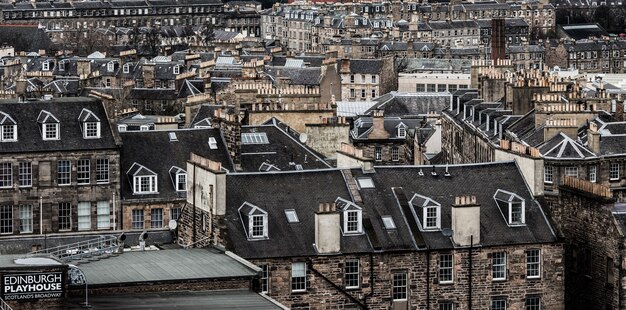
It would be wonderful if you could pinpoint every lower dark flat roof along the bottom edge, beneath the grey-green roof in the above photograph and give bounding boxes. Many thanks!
[69,290,286,310]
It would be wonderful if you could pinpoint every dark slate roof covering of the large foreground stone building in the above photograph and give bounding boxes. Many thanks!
[225,161,557,259]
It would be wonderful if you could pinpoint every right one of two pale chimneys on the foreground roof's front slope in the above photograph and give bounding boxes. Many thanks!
[452,196,480,246]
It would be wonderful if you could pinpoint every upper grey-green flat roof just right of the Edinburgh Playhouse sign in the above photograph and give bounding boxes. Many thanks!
[78,248,257,286]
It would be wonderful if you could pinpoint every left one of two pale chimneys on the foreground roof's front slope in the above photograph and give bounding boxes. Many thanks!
[315,202,341,254]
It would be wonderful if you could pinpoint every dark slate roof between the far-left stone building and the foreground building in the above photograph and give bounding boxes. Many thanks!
[120,129,232,201]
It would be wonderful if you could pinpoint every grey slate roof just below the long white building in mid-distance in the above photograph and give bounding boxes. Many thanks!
[365,91,452,117]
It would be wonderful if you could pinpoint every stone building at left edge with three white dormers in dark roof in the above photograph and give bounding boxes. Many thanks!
[0,98,122,238]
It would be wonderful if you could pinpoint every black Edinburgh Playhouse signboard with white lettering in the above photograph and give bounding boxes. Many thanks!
[2,272,63,300]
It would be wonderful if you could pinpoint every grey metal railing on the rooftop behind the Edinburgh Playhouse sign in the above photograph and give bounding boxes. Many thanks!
[27,235,119,262]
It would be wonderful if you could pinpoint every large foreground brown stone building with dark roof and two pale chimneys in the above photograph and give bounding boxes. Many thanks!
[181,154,564,309]
